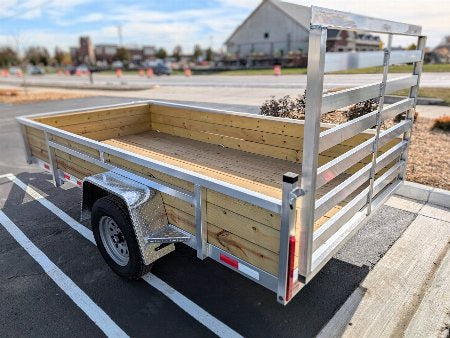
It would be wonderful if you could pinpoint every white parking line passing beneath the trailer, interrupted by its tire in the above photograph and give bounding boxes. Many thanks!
[4,174,242,337]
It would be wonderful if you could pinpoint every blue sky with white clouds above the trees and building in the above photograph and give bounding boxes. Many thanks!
[0,0,450,52]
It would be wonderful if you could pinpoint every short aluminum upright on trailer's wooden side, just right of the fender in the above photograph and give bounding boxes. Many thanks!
[194,184,208,259]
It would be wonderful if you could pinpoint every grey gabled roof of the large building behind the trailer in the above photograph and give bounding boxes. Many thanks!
[225,0,311,43]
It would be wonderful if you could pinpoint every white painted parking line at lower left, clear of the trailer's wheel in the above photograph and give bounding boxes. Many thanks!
[0,210,128,337]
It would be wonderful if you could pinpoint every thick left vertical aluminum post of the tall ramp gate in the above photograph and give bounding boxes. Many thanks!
[299,25,327,281]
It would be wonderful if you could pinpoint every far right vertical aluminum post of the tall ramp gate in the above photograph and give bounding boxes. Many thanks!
[399,36,427,181]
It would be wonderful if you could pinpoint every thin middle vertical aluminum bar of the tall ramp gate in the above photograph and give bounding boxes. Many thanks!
[367,34,392,215]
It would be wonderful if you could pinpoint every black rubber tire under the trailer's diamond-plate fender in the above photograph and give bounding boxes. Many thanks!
[91,196,152,280]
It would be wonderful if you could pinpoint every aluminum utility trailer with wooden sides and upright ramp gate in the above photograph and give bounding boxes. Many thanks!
[18,7,425,304]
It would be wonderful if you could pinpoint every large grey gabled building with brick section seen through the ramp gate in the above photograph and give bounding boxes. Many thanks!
[225,0,380,57]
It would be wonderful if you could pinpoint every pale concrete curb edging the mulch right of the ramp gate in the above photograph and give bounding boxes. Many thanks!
[396,181,450,208]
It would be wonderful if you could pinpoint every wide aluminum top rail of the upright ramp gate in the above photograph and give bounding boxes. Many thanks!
[311,6,422,36]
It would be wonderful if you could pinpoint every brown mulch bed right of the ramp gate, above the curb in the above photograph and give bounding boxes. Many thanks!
[406,117,450,190]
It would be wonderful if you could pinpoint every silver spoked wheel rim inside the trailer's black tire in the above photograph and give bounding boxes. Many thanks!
[99,216,130,266]
